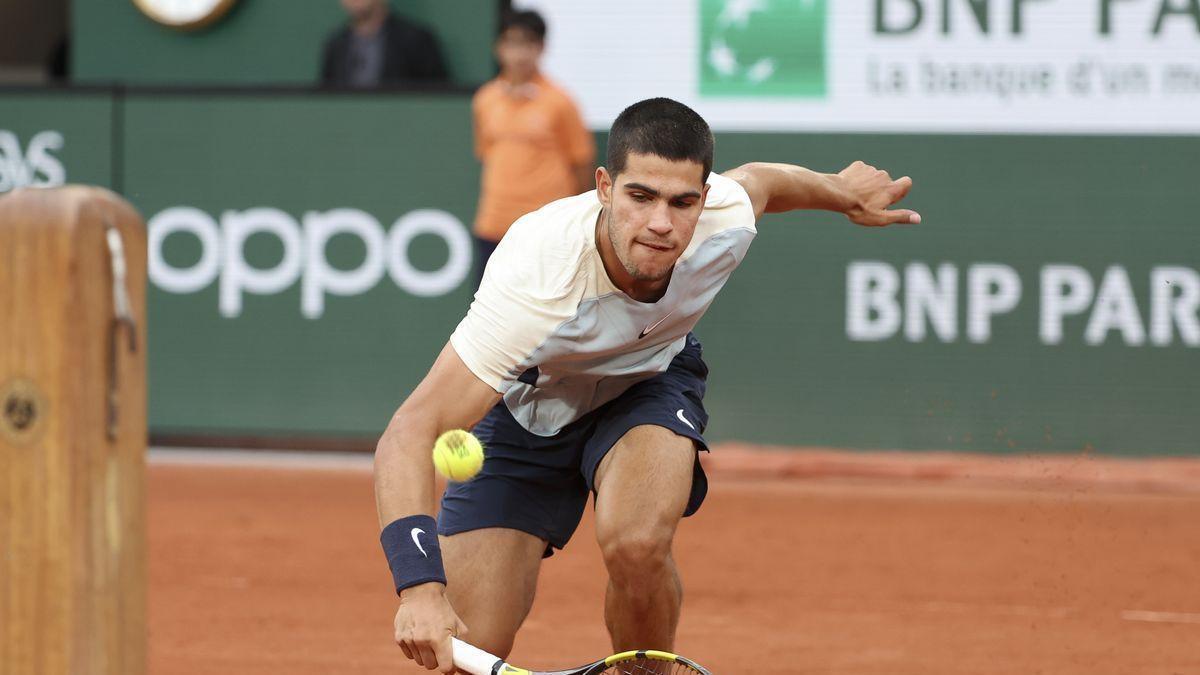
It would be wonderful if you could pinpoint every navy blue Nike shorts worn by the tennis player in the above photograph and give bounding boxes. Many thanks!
[438,334,708,556]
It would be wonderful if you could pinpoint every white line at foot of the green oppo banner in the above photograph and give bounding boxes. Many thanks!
[146,448,373,472]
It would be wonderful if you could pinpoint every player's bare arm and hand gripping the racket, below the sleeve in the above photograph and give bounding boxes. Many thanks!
[374,342,500,673]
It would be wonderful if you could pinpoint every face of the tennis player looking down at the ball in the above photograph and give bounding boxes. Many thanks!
[596,154,708,293]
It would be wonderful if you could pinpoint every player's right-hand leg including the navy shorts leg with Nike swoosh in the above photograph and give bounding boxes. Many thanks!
[581,335,708,651]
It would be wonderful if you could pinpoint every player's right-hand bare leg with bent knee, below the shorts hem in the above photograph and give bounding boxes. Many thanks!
[595,425,696,651]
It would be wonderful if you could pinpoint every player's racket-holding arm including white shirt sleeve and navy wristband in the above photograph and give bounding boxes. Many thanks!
[376,215,577,673]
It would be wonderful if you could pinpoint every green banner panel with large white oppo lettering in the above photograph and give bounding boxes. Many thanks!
[118,95,479,436]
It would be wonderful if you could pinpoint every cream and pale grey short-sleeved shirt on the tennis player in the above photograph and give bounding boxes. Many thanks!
[450,174,757,436]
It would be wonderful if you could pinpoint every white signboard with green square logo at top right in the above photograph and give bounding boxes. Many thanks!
[516,0,1200,135]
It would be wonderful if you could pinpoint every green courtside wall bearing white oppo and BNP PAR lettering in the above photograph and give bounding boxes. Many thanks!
[0,92,1200,454]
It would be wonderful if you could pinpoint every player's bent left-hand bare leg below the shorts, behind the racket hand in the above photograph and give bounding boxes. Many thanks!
[440,527,546,657]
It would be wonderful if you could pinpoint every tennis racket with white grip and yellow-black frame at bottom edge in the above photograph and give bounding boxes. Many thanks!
[451,638,712,675]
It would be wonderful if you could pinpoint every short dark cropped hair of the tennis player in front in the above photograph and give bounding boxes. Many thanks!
[607,98,713,181]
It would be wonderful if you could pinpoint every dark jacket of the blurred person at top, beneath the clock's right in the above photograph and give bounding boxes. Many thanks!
[320,14,448,86]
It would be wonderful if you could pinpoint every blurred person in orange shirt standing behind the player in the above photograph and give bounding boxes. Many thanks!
[472,11,595,286]
